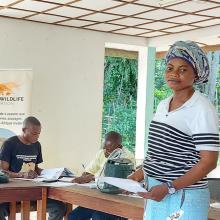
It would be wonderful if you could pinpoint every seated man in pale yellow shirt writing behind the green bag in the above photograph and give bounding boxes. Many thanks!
[68,131,135,220]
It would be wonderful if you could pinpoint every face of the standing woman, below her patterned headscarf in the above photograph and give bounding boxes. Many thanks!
[165,58,196,91]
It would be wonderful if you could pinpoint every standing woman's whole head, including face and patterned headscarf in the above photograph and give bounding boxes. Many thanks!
[165,41,210,90]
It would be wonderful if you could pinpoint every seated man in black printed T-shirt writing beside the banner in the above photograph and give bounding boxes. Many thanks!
[0,117,66,220]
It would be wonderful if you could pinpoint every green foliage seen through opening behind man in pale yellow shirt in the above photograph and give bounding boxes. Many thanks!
[102,56,137,152]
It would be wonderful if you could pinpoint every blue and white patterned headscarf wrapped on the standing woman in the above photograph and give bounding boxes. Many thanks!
[165,41,210,84]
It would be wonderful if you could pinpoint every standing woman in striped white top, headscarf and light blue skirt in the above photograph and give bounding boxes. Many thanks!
[140,41,220,220]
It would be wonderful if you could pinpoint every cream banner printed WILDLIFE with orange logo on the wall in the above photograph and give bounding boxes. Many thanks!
[0,69,32,146]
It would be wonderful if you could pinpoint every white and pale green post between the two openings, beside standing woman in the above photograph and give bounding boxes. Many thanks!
[135,47,156,160]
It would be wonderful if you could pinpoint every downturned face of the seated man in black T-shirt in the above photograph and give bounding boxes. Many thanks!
[23,125,41,144]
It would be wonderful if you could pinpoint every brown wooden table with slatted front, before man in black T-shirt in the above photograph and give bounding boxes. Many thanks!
[0,179,47,220]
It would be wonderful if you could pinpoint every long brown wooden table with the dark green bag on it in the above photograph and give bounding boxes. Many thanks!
[47,186,144,220]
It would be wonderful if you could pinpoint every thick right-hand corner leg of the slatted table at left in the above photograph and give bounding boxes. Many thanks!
[37,188,47,220]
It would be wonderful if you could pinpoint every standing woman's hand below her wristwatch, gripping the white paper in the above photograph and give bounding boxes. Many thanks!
[138,184,168,202]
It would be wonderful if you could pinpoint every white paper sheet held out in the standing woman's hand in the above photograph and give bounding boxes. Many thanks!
[99,177,147,193]
